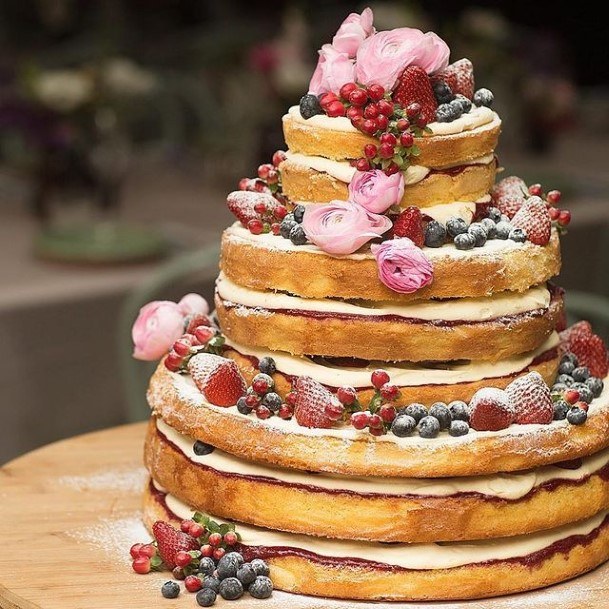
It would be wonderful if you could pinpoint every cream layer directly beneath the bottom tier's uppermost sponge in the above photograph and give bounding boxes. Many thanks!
[156,419,609,500]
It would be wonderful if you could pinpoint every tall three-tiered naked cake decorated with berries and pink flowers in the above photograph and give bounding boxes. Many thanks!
[134,9,609,600]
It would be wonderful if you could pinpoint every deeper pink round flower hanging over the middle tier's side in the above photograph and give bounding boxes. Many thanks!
[370,237,433,294]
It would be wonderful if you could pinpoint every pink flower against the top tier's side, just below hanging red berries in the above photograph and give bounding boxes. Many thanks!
[349,169,404,214]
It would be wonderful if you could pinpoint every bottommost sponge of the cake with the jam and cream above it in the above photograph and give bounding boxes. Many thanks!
[144,481,609,601]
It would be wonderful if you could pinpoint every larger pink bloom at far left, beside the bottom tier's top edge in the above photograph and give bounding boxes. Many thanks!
[131,300,184,361]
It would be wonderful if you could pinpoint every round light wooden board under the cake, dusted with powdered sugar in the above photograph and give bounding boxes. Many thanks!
[0,423,609,609]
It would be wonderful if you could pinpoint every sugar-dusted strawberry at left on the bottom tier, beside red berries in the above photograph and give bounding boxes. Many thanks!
[188,353,247,406]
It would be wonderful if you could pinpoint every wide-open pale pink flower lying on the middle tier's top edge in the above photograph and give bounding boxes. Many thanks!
[302,201,391,256]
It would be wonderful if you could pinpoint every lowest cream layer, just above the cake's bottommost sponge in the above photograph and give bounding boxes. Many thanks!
[158,484,609,570]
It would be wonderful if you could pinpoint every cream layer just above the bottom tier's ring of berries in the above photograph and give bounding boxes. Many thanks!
[226,332,560,387]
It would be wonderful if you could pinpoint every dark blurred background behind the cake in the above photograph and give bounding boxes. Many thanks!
[0,0,609,462]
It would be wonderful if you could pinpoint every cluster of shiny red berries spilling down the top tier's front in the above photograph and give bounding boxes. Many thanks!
[320,82,427,175]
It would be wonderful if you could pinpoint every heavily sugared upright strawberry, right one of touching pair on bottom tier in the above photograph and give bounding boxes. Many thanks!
[505,372,554,425]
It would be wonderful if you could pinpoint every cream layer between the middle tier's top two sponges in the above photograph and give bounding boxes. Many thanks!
[216,273,551,322]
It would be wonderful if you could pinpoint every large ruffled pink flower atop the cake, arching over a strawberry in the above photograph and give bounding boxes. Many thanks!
[355,27,450,91]
